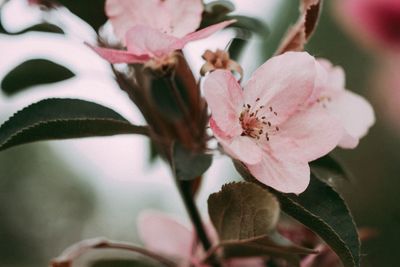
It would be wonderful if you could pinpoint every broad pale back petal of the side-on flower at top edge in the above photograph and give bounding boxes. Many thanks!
[105,0,203,41]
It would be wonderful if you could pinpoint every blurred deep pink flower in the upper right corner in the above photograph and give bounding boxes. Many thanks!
[335,0,400,51]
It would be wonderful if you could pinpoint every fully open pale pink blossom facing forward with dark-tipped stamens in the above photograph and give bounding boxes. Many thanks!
[204,52,344,194]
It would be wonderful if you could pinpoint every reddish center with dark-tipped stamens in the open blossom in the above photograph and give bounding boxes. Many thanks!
[239,98,279,141]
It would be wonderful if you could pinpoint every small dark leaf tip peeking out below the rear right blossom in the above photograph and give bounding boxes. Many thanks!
[310,154,352,184]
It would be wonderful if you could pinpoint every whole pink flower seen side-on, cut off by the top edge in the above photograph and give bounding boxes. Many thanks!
[92,0,235,63]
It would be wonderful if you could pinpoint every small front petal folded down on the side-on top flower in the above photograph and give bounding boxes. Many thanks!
[126,25,179,57]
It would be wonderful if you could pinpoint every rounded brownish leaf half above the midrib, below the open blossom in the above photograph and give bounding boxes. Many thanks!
[208,182,280,241]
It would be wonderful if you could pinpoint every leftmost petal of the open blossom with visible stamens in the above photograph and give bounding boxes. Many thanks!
[203,70,243,137]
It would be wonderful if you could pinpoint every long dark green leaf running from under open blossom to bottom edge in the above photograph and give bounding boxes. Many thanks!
[235,162,360,267]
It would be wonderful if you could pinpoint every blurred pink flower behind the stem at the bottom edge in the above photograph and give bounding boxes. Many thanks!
[138,211,264,267]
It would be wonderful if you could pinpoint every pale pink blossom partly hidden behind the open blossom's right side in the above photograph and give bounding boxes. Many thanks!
[317,59,375,148]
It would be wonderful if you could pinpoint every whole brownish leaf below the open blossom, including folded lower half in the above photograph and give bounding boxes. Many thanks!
[208,182,313,262]
